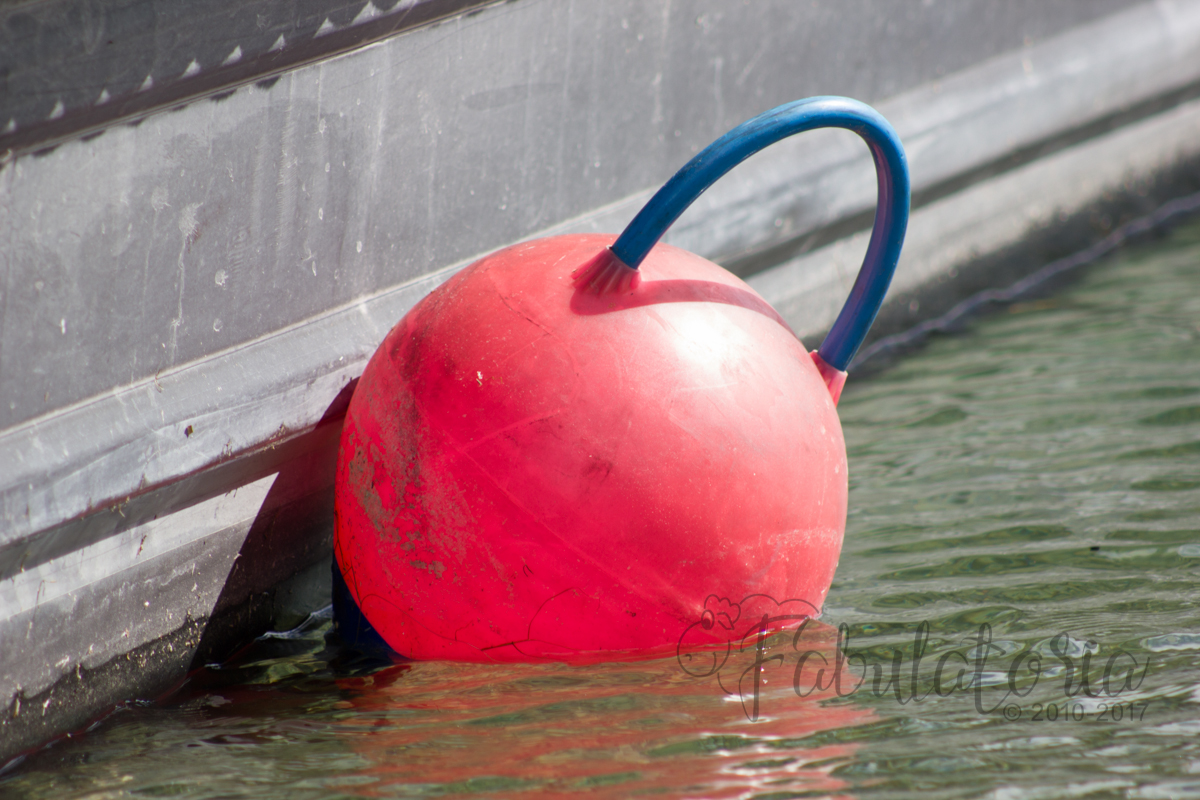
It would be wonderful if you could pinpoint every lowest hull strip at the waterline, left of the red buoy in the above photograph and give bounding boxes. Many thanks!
[0,470,330,760]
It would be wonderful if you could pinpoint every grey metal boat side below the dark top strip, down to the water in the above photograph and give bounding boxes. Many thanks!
[0,0,1200,758]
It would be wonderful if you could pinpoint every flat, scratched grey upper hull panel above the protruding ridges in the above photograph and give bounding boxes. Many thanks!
[0,0,1129,429]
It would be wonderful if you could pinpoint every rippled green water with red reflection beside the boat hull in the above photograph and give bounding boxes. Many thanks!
[0,223,1200,800]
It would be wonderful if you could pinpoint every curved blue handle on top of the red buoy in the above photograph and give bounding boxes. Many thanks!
[612,97,910,371]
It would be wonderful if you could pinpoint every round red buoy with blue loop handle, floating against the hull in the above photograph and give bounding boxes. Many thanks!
[335,98,908,661]
